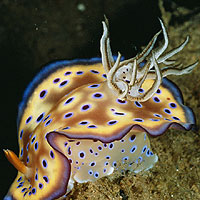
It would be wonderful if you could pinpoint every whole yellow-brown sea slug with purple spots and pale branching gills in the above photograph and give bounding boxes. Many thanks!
[4,20,198,200]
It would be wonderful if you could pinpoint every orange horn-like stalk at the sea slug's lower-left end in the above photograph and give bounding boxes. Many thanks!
[3,149,30,177]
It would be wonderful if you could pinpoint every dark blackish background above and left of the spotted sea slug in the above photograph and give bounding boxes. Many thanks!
[0,0,199,199]
